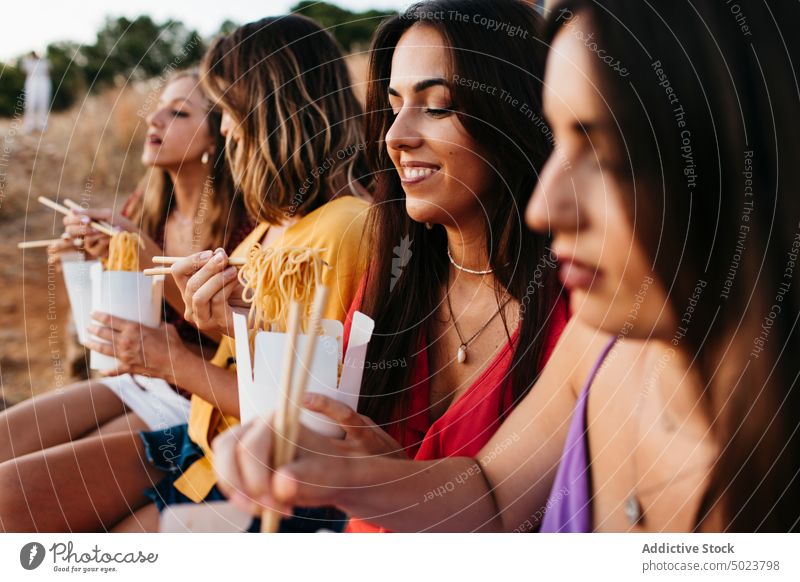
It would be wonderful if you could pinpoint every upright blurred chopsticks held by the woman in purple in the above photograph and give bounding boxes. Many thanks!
[261,287,328,533]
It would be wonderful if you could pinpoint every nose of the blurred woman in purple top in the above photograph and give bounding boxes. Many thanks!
[525,152,579,235]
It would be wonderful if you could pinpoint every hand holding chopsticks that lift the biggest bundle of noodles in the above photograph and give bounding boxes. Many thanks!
[172,249,242,337]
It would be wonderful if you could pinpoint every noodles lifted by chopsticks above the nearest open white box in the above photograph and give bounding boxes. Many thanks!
[239,243,327,331]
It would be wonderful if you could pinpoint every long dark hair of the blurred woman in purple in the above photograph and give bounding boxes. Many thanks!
[550,0,800,531]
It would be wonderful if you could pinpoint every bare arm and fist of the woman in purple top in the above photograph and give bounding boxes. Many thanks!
[214,323,605,531]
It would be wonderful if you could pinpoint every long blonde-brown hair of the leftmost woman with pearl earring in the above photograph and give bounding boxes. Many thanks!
[128,69,247,248]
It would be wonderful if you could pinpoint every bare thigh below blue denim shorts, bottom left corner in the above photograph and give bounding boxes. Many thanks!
[0,432,163,532]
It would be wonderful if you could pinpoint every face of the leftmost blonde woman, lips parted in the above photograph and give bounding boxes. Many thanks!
[142,77,214,169]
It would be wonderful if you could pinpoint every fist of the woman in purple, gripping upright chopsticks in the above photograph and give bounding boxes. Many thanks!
[212,419,352,515]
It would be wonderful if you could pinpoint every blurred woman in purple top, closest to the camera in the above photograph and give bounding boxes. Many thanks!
[215,0,800,532]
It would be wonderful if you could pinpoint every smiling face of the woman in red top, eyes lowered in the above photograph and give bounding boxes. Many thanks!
[386,25,491,227]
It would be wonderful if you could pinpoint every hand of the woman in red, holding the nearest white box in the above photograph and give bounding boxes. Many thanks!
[304,393,408,459]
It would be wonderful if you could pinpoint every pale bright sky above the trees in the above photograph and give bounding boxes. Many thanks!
[0,0,412,61]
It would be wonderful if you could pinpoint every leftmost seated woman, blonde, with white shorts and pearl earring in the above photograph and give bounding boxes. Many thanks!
[0,71,255,461]
